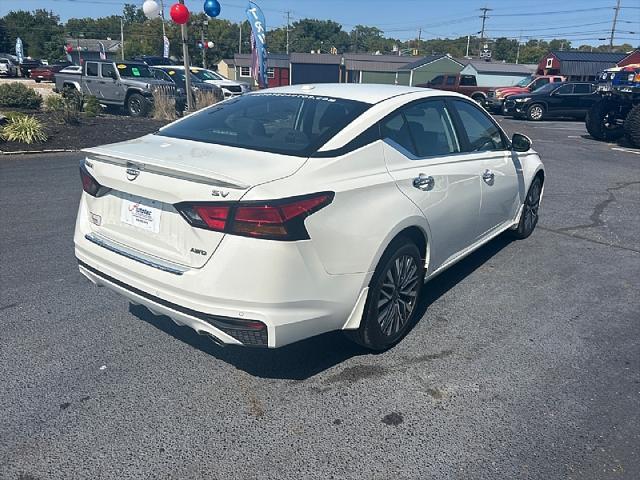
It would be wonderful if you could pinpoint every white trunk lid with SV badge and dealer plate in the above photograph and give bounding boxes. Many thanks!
[84,135,306,268]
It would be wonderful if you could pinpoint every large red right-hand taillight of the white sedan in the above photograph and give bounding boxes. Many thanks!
[175,192,334,241]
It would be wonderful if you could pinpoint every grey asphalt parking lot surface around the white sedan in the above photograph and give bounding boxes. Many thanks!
[0,119,640,480]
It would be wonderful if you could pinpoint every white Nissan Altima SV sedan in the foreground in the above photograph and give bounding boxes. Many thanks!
[75,84,545,350]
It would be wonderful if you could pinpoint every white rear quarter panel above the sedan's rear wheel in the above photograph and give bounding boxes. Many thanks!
[243,141,428,275]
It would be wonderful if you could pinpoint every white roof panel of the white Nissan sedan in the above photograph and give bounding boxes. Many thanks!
[250,83,461,103]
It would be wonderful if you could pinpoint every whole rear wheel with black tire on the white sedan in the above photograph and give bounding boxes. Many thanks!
[348,237,424,351]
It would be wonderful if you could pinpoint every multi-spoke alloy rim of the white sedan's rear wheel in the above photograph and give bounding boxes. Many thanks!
[377,255,420,337]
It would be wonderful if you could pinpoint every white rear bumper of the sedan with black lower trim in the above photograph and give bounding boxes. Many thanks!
[74,204,369,348]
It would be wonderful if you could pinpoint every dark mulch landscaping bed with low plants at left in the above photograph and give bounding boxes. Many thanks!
[0,112,169,153]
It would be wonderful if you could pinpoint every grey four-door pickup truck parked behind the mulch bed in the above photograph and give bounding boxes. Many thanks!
[54,60,176,117]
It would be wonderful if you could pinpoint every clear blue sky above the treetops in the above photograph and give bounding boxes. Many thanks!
[0,0,640,45]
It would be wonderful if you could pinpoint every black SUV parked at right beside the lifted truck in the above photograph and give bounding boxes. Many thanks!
[502,82,598,121]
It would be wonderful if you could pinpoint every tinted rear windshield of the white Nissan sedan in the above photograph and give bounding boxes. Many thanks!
[158,93,371,157]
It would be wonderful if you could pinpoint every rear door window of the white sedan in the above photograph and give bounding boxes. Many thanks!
[403,100,460,157]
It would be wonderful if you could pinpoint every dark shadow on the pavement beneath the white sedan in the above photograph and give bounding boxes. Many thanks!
[129,235,511,380]
